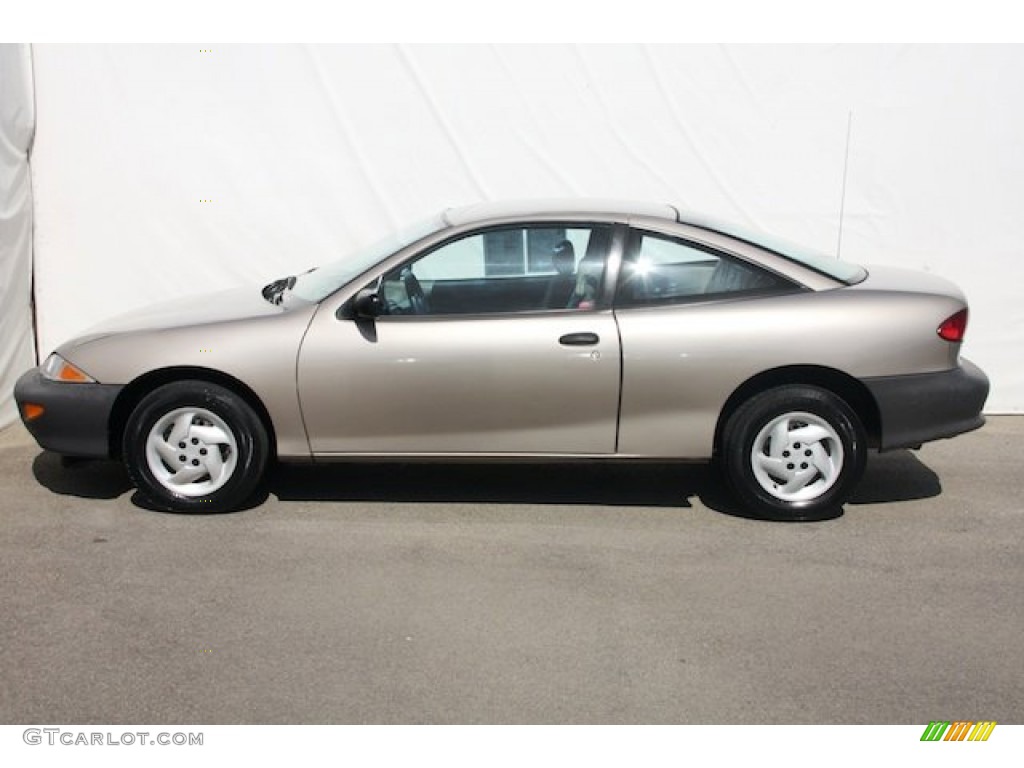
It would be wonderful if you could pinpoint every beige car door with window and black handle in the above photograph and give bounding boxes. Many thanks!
[298,224,621,456]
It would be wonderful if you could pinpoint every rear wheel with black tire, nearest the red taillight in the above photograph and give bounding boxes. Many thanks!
[720,385,867,521]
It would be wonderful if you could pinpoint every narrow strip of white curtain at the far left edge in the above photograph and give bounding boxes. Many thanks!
[0,44,35,429]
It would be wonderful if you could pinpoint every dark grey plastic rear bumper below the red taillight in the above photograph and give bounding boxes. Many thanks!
[863,359,988,451]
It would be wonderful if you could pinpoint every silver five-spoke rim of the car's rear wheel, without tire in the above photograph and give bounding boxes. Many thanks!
[751,412,843,502]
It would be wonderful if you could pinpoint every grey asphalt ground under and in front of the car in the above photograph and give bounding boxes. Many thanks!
[0,417,1024,724]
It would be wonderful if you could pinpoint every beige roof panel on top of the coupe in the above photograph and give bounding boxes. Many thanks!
[442,198,679,226]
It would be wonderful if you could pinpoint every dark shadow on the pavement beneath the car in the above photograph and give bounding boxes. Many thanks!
[32,451,942,519]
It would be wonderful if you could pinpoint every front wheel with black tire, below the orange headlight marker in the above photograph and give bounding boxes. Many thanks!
[122,380,269,512]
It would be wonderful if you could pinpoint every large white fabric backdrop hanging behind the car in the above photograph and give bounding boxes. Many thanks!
[8,45,1024,423]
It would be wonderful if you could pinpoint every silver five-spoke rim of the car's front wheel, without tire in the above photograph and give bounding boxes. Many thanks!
[145,408,239,497]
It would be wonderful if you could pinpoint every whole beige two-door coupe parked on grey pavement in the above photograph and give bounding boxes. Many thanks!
[15,201,988,519]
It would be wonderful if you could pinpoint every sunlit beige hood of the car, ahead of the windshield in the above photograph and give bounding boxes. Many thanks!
[78,286,287,343]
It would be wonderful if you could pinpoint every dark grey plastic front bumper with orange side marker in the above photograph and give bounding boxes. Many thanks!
[14,368,123,459]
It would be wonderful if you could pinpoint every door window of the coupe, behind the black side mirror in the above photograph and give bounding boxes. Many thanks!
[379,224,611,315]
